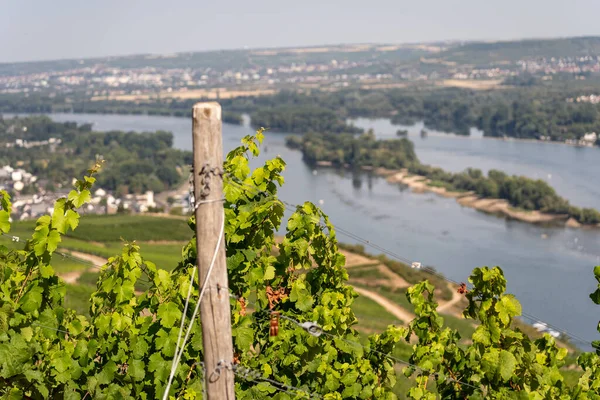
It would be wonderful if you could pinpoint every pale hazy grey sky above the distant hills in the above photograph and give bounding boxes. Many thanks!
[0,0,600,62]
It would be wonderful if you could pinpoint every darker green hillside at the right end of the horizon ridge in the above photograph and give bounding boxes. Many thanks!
[436,36,600,65]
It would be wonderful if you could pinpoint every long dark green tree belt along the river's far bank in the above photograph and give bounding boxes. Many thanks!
[0,86,600,141]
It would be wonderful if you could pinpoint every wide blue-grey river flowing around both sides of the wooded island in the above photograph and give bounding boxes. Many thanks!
[11,114,600,341]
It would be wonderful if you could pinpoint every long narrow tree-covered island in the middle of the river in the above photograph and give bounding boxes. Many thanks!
[286,132,600,225]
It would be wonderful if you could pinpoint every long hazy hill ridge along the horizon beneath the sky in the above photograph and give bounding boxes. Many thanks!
[0,36,600,76]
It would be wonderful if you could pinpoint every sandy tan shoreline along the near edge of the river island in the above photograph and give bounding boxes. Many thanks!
[363,167,600,228]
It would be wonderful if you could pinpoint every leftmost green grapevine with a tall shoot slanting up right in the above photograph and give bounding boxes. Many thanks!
[0,159,101,398]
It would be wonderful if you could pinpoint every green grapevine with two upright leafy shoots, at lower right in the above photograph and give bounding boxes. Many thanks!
[405,267,571,399]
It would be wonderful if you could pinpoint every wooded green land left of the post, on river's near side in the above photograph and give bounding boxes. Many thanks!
[0,116,192,194]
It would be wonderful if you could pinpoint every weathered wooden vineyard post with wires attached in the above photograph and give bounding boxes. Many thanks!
[192,102,235,400]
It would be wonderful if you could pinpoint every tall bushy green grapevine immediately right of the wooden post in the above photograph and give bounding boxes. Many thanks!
[219,133,397,398]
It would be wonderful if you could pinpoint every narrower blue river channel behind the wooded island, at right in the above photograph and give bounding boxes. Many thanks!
[353,118,600,209]
